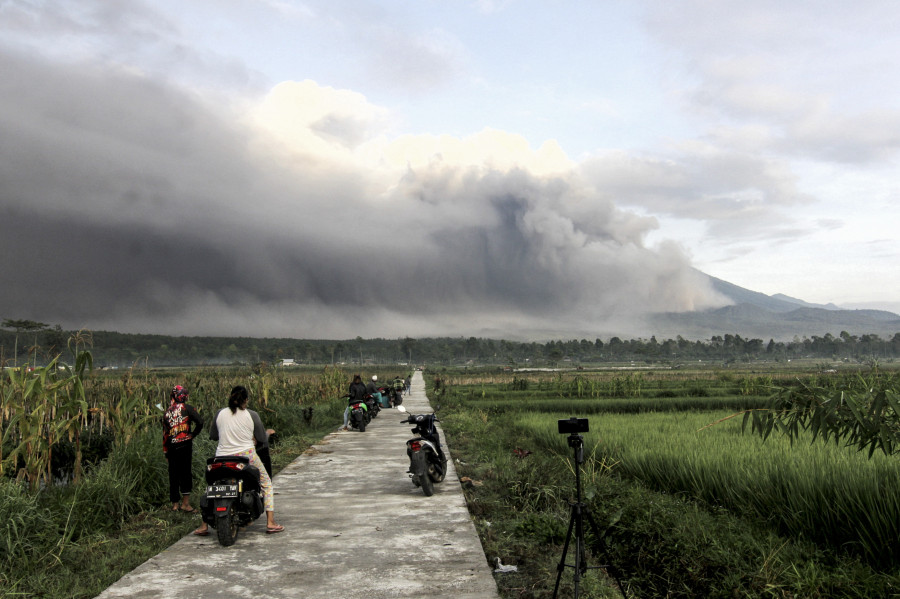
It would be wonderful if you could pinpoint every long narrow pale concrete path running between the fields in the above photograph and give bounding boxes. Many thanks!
[98,372,498,599]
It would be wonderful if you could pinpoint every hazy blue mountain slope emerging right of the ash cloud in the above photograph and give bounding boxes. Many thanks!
[651,277,900,340]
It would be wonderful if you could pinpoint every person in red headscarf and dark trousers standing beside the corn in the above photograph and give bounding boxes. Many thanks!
[162,385,203,513]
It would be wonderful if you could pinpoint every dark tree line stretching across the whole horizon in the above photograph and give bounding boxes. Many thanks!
[0,320,900,368]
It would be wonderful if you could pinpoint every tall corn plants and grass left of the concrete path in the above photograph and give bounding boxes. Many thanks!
[0,352,356,598]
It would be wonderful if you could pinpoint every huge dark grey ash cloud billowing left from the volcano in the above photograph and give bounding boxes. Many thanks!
[0,47,722,338]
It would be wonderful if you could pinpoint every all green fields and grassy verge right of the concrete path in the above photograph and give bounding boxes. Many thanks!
[436,365,900,598]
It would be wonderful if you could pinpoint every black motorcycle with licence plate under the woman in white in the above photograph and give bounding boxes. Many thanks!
[200,456,265,547]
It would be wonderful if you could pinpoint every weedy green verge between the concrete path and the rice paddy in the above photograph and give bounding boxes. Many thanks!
[441,390,898,599]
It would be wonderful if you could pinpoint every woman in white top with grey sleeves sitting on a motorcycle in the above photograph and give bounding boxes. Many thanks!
[194,385,284,536]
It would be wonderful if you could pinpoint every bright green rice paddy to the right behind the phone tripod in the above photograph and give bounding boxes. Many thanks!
[516,412,900,566]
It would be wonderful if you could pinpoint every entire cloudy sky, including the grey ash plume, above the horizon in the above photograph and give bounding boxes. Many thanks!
[0,0,900,338]
